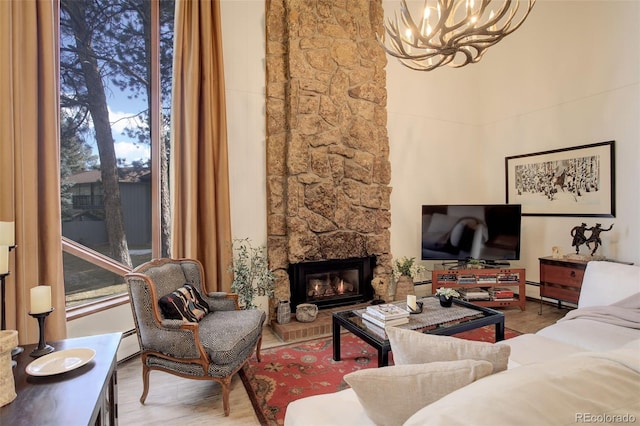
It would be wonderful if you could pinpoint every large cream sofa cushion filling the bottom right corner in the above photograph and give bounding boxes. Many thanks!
[405,349,640,426]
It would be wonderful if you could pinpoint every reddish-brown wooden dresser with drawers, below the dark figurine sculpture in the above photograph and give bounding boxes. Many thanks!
[540,257,589,308]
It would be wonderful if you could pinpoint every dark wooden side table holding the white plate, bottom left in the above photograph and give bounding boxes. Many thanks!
[0,333,122,426]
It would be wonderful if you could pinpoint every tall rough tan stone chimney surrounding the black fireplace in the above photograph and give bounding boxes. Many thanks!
[266,0,391,316]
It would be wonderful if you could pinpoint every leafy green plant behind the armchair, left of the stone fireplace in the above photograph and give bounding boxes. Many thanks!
[229,238,275,310]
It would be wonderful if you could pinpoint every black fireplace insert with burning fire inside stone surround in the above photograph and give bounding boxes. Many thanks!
[289,257,375,310]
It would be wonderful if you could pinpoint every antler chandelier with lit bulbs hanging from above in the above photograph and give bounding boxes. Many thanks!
[378,0,536,71]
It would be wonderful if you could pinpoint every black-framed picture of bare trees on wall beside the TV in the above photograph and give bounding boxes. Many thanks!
[505,141,616,217]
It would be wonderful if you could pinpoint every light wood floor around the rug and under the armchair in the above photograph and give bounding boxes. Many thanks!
[118,301,568,426]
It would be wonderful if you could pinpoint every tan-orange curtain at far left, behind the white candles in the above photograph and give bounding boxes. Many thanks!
[0,0,66,344]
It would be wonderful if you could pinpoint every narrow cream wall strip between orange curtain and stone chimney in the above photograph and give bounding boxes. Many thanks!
[220,0,267,245]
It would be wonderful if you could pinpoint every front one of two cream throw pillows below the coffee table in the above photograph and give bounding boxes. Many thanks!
[344,360,493,426]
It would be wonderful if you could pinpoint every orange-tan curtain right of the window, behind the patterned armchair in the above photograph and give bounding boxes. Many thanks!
[170,0,232,291]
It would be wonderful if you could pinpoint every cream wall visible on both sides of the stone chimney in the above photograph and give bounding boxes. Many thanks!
[221,0,640,281]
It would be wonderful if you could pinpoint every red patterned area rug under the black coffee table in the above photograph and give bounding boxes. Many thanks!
[240,326,520,426]
